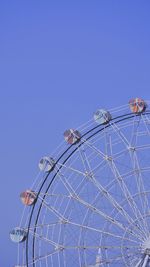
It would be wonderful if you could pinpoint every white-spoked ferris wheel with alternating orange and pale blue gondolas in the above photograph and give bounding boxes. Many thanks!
[10,98,150,267]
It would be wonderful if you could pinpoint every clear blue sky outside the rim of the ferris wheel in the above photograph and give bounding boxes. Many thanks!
[0,0,150,267]
